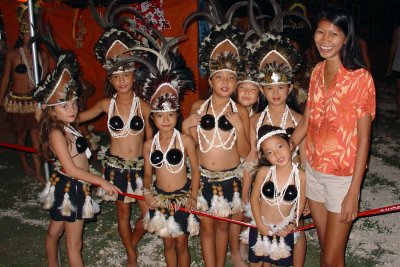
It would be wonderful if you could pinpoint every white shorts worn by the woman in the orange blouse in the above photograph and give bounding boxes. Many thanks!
[306,162,353,213]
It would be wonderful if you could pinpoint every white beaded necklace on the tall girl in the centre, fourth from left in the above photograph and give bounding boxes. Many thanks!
[197,96,237,153]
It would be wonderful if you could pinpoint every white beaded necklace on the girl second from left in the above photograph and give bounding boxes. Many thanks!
[107,94,144,138]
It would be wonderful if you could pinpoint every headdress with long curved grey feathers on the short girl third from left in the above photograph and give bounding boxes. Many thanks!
[103,16,195,112]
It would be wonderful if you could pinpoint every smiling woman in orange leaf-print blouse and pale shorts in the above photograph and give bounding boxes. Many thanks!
[292,4,376,266]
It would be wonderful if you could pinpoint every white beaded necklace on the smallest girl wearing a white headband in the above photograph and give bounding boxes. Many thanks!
[261,162,301,225]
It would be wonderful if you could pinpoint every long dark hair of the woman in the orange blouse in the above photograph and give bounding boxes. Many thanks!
[317,5,365,70]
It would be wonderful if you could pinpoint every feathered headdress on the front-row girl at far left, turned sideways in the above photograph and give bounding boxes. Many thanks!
[33,51,82,106]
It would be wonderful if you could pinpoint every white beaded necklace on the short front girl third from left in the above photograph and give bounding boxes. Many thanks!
[149,129,185,173]
